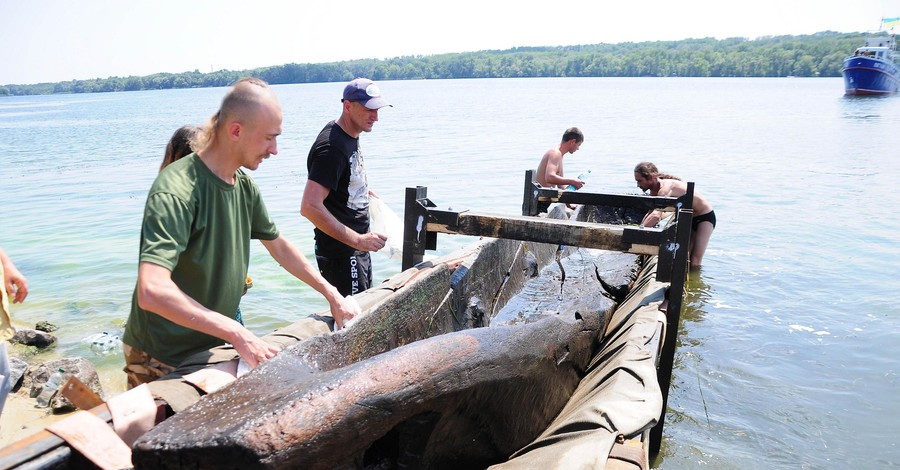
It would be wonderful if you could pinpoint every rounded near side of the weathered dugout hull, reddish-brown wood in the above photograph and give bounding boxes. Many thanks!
[133,319,599,469]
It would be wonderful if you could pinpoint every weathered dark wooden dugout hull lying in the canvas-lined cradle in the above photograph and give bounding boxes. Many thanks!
[133,207,652,468]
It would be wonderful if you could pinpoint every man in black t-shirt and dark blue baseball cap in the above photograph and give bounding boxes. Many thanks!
[300,78,392,296]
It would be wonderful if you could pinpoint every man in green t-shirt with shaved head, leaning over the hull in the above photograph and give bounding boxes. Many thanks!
[122,78,353,388]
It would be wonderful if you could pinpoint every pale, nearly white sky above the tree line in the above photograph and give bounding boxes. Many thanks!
[0,0,900,85]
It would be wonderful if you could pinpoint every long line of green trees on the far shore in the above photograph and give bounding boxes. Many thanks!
[0,31,866,96]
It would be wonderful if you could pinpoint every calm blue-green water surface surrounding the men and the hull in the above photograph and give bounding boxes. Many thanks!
[0,78,900,469]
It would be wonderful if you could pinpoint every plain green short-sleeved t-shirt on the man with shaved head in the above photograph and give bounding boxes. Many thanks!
[122,154,278,366]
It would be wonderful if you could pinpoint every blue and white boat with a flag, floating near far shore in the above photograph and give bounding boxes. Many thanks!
[841,18,900,95]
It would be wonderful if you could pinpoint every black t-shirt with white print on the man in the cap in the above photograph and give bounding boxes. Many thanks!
[306,121,369,256]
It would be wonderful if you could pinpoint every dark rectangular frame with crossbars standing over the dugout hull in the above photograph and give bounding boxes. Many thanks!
[402,170,694,456]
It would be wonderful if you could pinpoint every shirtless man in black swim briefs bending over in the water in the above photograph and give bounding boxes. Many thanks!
[634,162,716,269]
